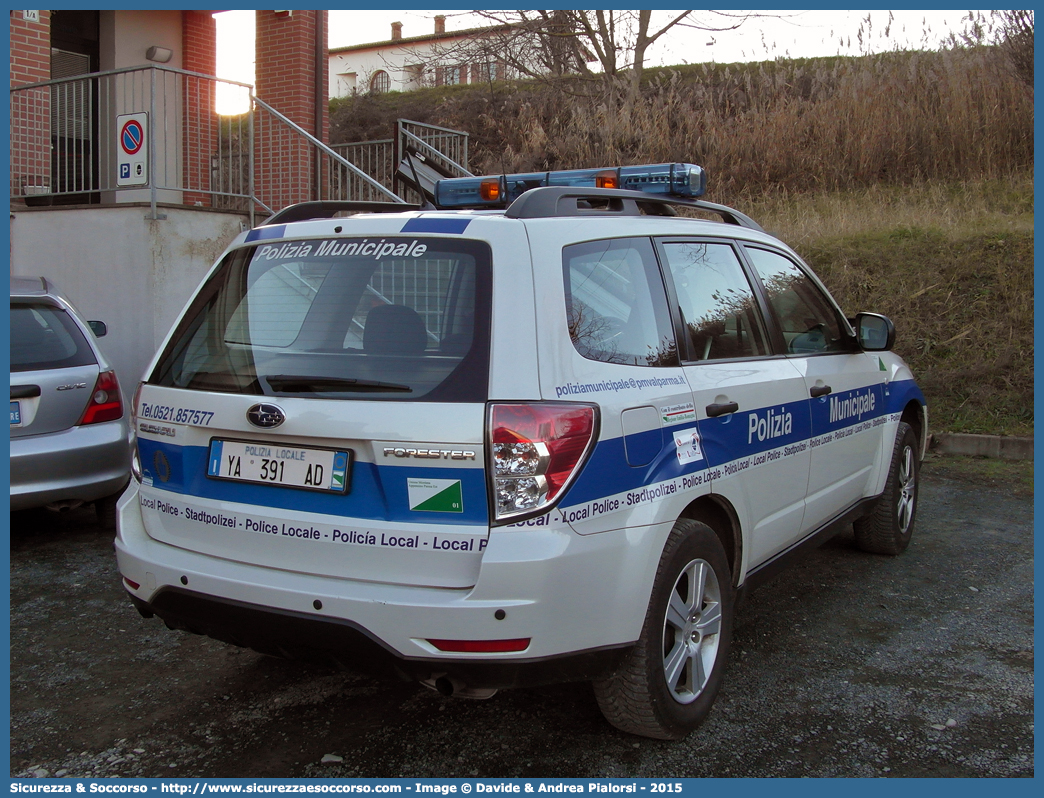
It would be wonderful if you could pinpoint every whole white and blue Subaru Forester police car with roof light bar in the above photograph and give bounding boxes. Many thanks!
[116,164,927,738]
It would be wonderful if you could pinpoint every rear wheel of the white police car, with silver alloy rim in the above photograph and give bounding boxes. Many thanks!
[594,518,734,740]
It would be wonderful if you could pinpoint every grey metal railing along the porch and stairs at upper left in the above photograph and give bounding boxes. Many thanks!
[9,65,471,215]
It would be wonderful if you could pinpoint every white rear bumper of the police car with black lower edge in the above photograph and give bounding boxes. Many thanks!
[116,485,670,687]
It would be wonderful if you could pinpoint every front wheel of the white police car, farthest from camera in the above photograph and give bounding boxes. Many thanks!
[853,421,921,555]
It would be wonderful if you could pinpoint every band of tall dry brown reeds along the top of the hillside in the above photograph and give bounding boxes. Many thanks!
[332,47,1034,203]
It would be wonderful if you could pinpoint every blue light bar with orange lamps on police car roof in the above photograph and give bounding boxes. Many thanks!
[434,164,707,208]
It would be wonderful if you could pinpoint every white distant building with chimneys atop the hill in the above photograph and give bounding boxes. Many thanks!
[329,15,508,97]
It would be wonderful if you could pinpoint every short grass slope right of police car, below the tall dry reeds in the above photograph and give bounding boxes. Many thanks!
[742,175,1034,435]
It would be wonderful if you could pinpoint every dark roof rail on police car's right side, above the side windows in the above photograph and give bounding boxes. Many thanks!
[504,186,764,233]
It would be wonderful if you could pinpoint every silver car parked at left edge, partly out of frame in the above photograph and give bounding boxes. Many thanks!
[10,277,133,527]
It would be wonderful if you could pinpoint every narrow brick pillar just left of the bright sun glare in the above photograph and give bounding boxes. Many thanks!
[182,11,220,207]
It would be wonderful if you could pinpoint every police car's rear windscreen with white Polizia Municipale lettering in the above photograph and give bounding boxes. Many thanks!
[150,238,491,402]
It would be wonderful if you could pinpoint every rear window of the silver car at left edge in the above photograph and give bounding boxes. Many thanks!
[10,303,97,372]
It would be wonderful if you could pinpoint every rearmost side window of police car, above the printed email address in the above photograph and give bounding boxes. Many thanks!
[563,233,679,366]
